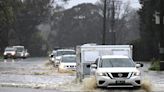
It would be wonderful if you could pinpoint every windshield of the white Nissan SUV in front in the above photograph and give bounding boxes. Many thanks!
[99,58,135,67]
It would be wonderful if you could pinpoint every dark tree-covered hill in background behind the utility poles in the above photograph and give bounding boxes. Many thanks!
[48,4,139,49]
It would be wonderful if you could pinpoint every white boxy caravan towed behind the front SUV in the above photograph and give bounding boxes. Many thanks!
[76,44,133,80]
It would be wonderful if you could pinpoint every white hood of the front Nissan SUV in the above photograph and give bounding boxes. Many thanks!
[97,67,139,73]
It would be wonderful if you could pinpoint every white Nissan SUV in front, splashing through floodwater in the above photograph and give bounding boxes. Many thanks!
[91,55,143,87]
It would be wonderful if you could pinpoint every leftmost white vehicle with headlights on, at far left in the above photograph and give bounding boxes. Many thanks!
[3,47,17,59]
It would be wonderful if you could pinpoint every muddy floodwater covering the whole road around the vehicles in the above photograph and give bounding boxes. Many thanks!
[0,58,164,92]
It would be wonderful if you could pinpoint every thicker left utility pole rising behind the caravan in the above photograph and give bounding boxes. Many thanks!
[102,0,107,45]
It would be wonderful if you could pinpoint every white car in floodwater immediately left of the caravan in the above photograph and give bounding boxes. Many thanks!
[58,55,76,71]
